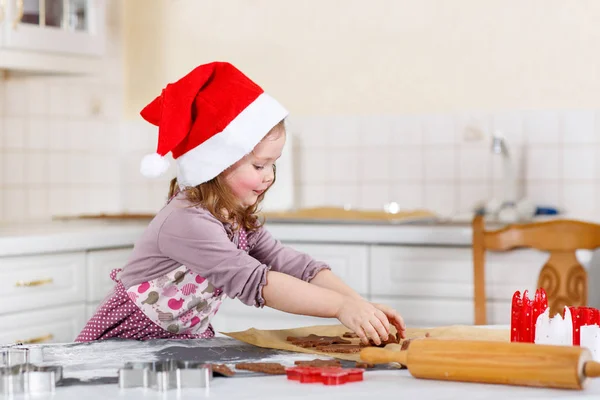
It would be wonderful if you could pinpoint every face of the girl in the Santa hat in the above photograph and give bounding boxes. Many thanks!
[224,127,285,207]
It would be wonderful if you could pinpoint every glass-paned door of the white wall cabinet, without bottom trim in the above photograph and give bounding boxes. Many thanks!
[4,0,106,55]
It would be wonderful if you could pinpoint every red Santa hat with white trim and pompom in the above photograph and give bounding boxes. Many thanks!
[140,62,288,186]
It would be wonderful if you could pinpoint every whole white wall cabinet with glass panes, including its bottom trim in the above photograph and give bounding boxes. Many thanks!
[0,0,106,73]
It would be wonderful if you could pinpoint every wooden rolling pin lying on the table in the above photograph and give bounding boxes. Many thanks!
[360,338,600,390]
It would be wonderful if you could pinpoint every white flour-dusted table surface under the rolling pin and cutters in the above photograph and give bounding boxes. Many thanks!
[11,337,600,400]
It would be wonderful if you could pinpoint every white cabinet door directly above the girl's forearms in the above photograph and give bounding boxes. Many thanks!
[284,242,369,296]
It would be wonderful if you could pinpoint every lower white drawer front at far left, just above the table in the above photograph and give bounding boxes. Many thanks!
[0,303,86,345]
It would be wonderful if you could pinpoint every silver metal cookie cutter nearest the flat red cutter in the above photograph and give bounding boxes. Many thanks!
[119,360,212,391]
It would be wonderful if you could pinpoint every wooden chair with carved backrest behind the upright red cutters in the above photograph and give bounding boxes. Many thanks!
[472,215,600,325]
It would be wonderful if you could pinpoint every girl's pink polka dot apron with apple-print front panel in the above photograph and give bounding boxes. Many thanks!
[75,229,248,342]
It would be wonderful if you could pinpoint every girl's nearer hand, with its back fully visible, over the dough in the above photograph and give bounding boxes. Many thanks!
[336,297,390,346]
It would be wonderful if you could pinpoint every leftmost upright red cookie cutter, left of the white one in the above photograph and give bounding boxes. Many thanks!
[510,288,548,343]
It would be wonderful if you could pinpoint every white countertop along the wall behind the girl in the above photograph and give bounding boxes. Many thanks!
[0,220,471,256]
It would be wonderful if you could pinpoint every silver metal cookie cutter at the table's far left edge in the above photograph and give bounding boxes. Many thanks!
[0,364,62,396]
